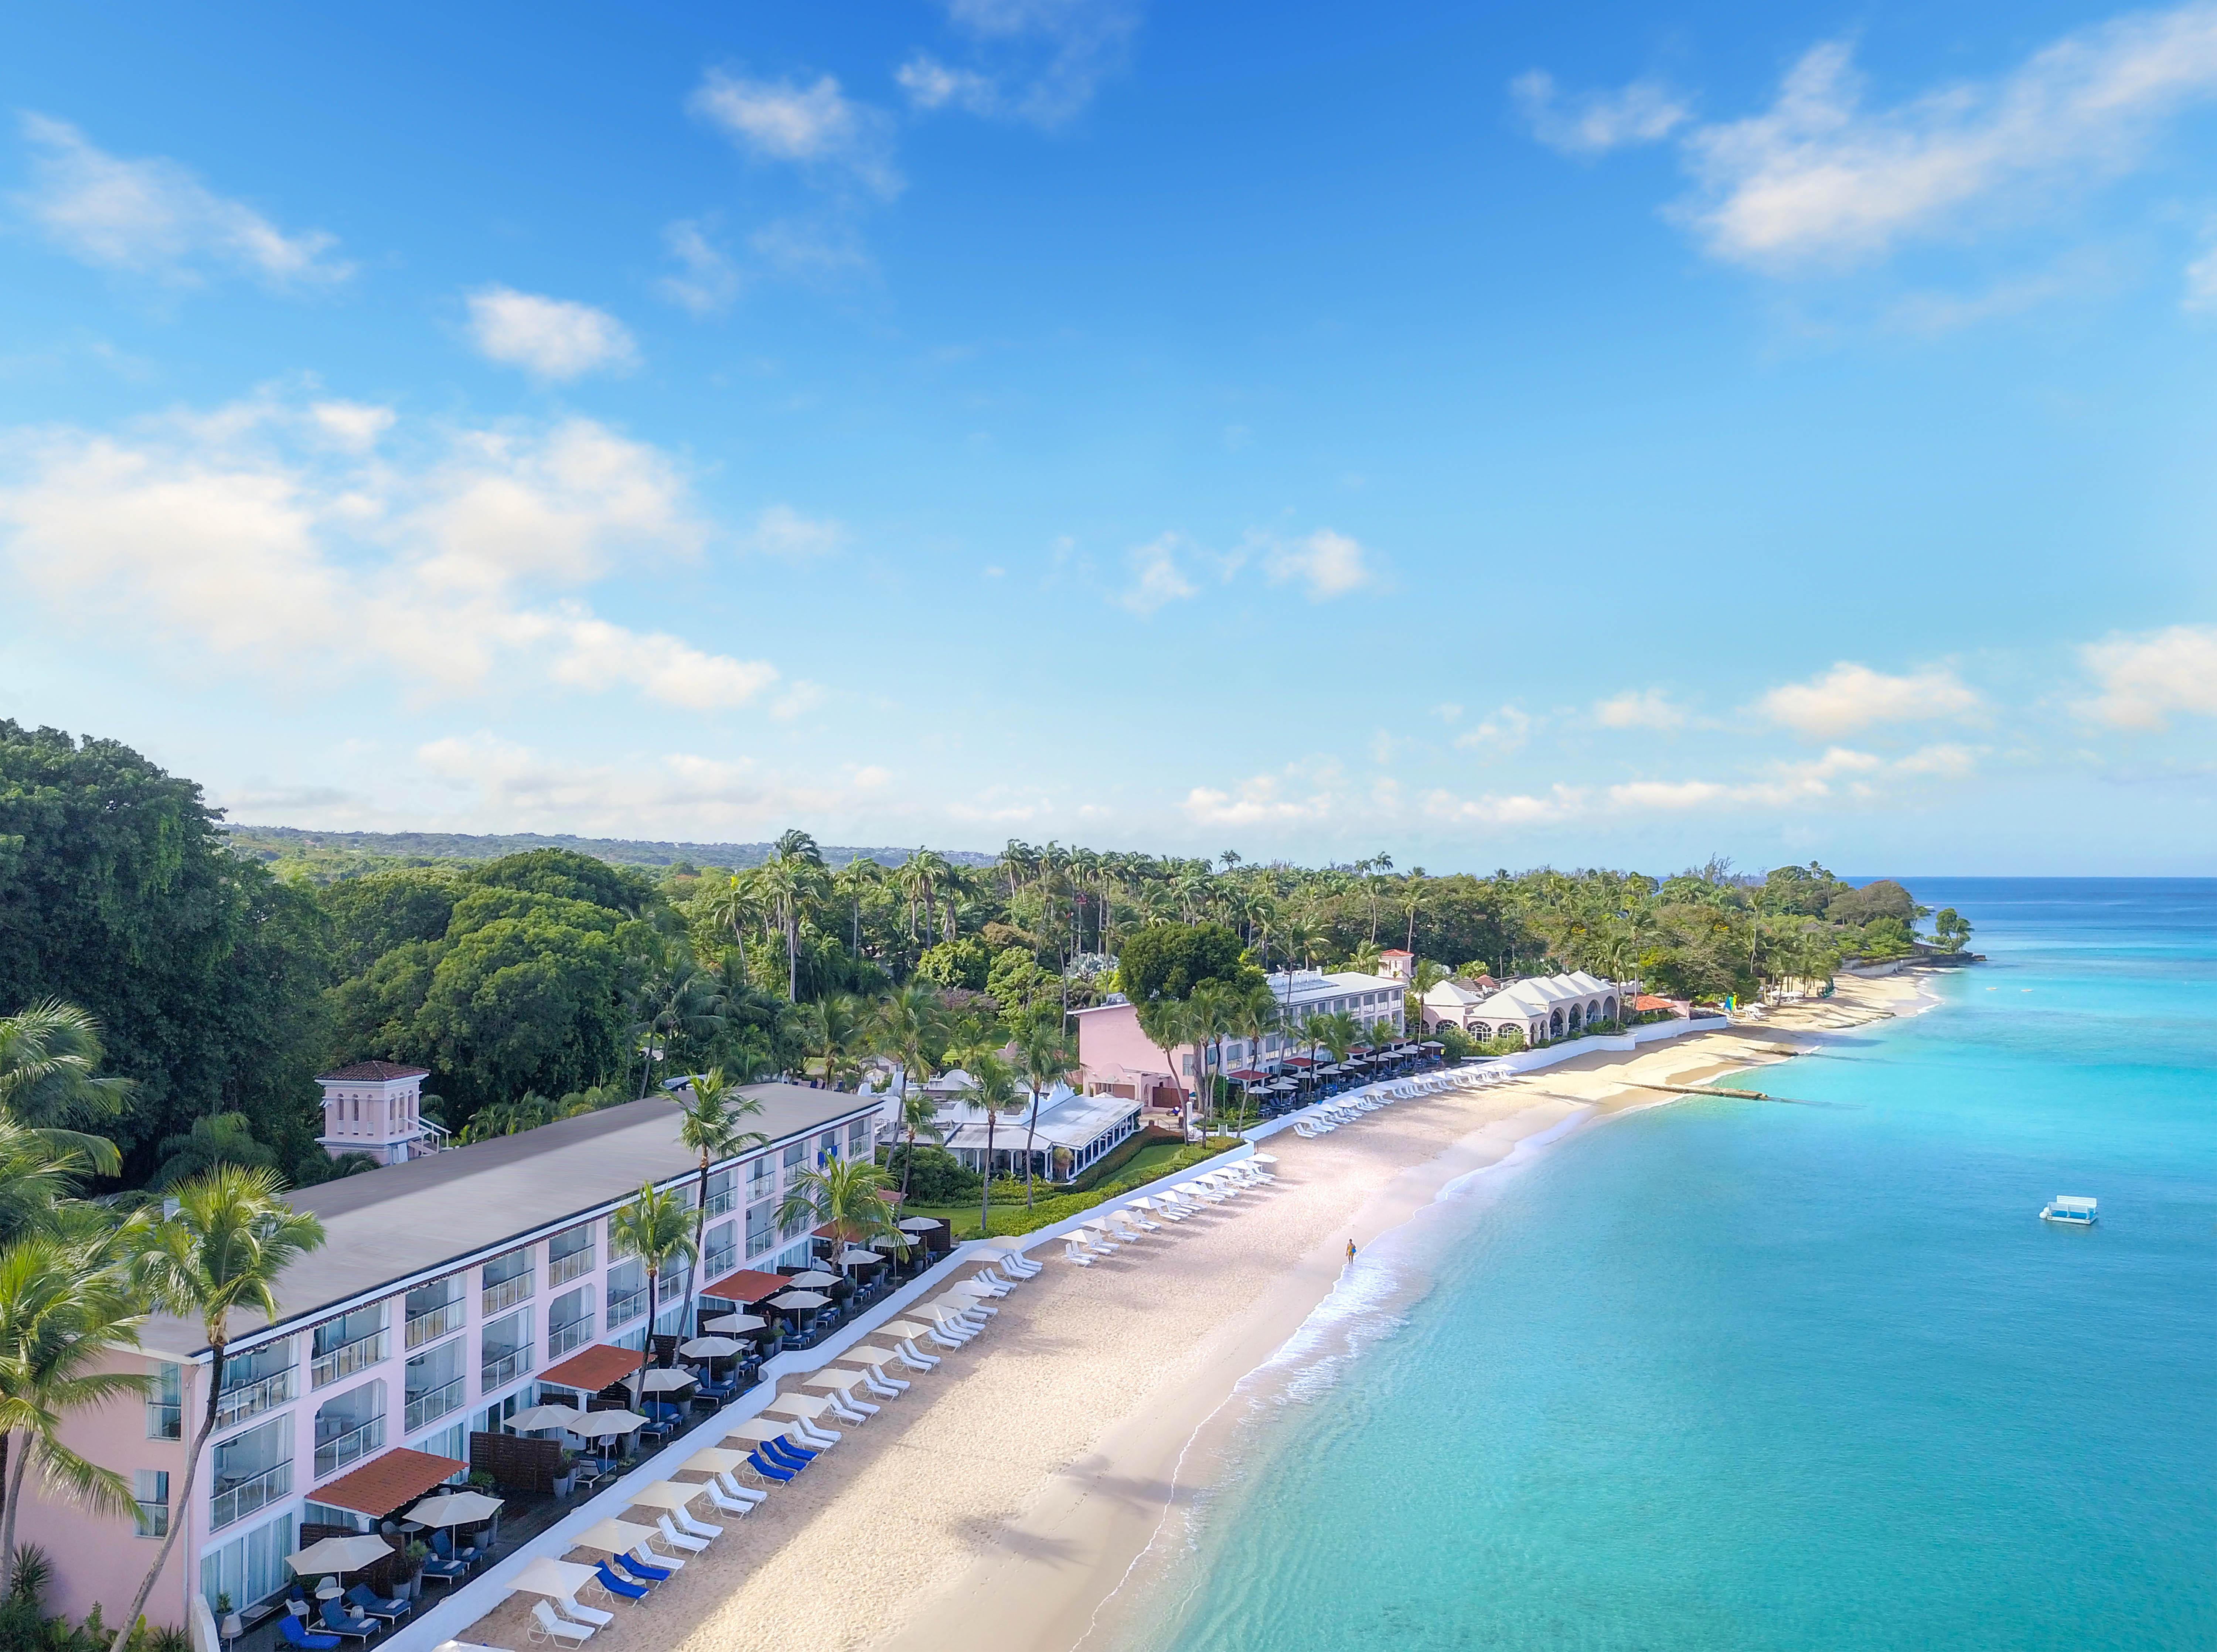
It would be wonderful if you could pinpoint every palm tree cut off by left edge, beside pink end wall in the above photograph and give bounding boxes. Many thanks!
[0,1229,149,1601]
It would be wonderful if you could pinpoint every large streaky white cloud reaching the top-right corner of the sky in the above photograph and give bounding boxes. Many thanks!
[1680,4,2217,270]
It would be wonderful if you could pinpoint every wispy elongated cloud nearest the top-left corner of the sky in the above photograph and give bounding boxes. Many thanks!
[13,113,353,288]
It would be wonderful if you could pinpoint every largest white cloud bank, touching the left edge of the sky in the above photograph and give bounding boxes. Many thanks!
[0,397,778,709]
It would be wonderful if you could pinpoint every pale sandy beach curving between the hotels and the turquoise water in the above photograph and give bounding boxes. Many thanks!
[463,976,1920,1652]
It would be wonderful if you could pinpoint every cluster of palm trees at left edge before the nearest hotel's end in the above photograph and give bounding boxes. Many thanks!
[0,1002,324,1652]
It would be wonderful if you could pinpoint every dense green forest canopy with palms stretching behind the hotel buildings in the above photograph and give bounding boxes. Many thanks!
[0,721,1969,1186]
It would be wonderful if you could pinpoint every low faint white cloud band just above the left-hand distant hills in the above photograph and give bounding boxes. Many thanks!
[415,732,900,841]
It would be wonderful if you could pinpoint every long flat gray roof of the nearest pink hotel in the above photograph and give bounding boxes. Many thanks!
[144,1084,885,1355]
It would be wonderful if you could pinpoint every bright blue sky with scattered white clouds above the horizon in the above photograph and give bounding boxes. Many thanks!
[0,0,2217,872]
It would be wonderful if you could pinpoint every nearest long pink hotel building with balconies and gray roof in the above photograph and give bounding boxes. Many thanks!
[16,1065,882,1628]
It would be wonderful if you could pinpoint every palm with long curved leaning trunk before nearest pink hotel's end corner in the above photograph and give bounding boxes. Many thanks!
[111,1164,324,1652]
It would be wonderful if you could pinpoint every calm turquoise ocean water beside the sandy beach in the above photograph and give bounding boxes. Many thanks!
[1120,878,2217,1652]
